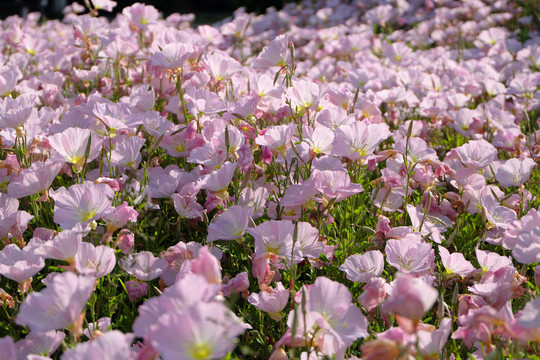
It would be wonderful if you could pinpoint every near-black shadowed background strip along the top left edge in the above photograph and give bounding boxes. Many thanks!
[0,0,291,19]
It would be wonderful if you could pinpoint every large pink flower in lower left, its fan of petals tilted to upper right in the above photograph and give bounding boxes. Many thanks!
[15,272,95,332]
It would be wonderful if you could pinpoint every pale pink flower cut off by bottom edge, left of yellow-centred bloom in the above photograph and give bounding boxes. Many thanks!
[62,330,135,360]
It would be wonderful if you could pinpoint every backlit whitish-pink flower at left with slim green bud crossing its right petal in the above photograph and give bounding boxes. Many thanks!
[48,127,102,169]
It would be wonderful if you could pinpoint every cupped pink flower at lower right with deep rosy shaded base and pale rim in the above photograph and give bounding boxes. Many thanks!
[382,274,438,322]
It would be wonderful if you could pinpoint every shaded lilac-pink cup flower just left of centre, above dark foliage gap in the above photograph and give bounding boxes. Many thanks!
[206,205,253,241]
